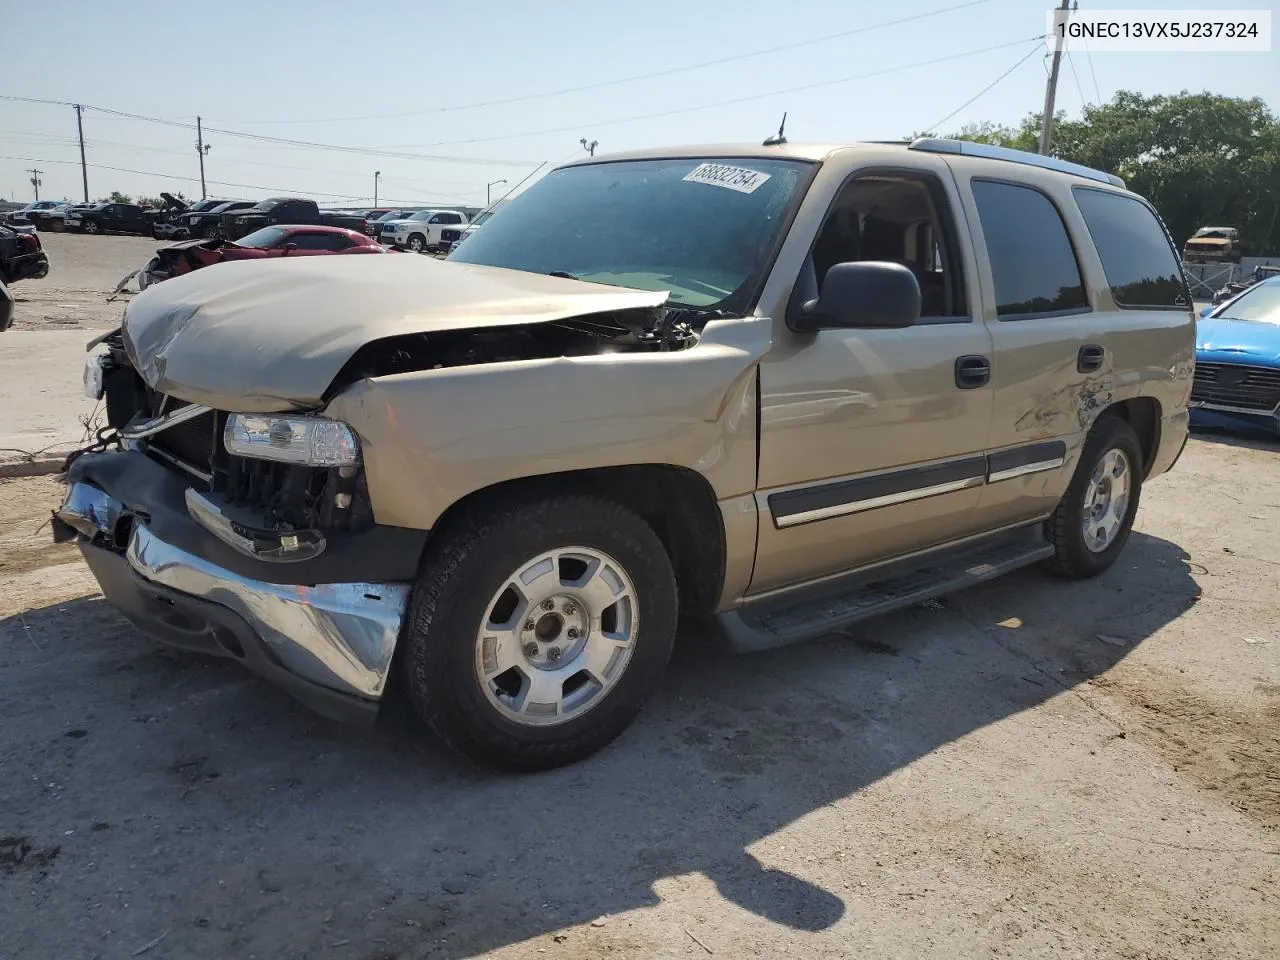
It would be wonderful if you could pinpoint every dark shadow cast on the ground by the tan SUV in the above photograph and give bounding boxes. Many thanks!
[0,534,1198,960]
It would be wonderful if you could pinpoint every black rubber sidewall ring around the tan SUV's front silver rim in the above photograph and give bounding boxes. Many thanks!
[404,502,677,759]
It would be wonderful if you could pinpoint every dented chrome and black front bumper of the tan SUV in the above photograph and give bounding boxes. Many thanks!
[54,463,422,724]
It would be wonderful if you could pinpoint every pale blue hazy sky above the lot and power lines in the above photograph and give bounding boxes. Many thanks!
[0,0,1280,206]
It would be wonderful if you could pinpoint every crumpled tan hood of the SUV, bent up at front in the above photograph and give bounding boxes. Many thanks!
[124,253,667,412]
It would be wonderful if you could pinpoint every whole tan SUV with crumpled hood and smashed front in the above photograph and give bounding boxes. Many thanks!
[54,140,1194,769]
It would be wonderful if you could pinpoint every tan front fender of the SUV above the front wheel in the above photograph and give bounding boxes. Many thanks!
[326,317,771,530]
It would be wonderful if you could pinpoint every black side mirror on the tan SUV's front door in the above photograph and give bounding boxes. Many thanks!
[792,260,920,332]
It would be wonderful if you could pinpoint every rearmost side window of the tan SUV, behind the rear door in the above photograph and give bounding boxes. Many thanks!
[1071,187,1189,310]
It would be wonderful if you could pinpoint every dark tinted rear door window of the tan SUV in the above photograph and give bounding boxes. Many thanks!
[973,180,1089,320]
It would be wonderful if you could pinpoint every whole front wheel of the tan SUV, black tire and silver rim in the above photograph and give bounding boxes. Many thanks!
[399,495,678,771]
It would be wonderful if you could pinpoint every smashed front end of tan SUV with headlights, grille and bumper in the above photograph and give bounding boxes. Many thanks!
[54,333,428,723]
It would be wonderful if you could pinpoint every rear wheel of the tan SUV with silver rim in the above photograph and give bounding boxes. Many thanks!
[1044,416,1144,580]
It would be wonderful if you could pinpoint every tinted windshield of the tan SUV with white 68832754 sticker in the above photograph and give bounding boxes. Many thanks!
[449,157,813,311]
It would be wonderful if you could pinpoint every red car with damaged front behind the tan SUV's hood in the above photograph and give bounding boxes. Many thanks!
[137,225,396,289]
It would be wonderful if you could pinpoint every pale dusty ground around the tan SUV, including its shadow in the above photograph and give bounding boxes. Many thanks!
[0,236,1280,960]
